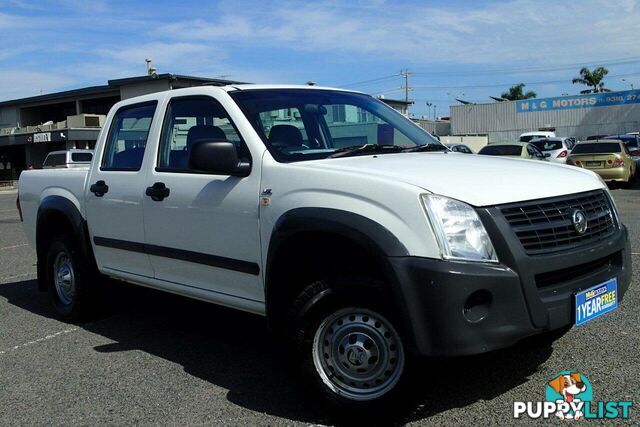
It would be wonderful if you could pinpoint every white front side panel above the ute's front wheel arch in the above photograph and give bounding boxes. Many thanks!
[260,152,440,269]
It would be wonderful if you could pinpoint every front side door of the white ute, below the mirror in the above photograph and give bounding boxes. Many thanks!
[144,96,264,312]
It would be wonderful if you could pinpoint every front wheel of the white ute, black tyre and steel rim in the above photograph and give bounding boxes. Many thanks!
[290,281,409,415]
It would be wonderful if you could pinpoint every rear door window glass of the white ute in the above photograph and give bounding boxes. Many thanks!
[101,102,157,171]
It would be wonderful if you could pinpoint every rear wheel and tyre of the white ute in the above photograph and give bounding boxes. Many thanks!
[46,235,99,321]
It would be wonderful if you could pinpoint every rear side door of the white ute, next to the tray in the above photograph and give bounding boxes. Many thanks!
[85,101,157,279]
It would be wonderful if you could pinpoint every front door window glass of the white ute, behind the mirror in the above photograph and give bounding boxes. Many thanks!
[158,97,250,172]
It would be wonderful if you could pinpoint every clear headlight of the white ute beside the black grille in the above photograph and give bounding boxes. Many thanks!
[422,194,498,262]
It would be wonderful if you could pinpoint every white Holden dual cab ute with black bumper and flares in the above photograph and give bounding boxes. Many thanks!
[19,85,631,408]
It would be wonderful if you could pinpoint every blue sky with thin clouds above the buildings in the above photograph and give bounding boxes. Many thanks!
[0,0,640,115]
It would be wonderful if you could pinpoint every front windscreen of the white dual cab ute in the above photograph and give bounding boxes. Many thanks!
[230,89,441,162]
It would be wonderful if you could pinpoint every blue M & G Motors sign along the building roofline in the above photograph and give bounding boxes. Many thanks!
[516,90,640,113]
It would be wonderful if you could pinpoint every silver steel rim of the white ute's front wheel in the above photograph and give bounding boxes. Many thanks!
[312,308,405,401]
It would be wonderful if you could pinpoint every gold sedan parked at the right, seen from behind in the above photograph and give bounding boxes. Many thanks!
[567,139,636,184]
